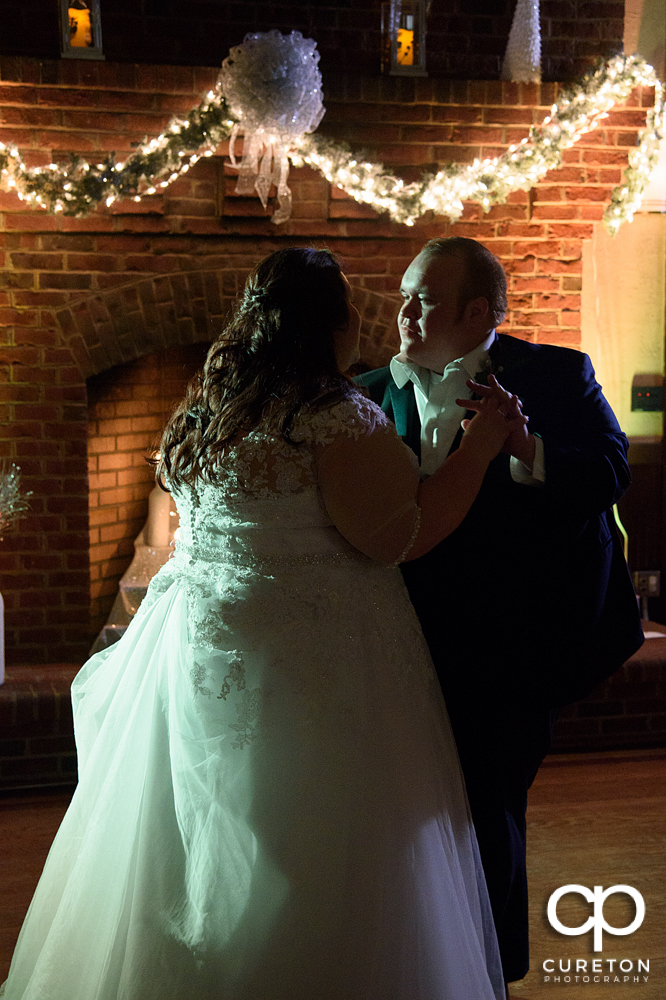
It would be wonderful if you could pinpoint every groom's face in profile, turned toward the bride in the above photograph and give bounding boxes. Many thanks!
[398,253,487,372]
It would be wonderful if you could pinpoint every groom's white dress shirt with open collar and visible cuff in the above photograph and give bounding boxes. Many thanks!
[390,330,546,486]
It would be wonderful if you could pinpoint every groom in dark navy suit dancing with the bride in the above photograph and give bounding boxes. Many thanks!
[356,237,643,982]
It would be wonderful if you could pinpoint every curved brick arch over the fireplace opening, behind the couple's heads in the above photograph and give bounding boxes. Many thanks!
[56,269,398,379]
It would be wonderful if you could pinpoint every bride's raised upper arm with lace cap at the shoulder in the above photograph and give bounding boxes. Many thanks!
[314,397,419,564]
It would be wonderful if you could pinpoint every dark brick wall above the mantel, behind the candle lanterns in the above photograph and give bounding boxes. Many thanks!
[0,0,624,81]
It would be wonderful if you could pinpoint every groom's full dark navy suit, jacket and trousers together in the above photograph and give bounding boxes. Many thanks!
[356,335,643,982]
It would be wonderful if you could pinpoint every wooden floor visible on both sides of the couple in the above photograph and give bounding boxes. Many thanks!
[0,749,666,1000]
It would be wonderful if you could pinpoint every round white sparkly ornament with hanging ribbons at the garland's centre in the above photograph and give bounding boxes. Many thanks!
[219,30,326,223]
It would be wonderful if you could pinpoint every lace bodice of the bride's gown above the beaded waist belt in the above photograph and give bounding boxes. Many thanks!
[160,393,416,564]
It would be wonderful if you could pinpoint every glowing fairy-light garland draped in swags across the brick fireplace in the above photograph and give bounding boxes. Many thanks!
[0,56,664,233]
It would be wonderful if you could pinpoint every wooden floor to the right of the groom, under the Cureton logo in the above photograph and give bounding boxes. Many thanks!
[510,750,666,1000]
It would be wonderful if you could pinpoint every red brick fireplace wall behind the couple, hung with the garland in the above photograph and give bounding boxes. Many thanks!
[0,57,650,663]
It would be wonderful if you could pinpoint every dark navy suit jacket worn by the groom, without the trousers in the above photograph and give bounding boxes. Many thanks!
[356,335,643,707]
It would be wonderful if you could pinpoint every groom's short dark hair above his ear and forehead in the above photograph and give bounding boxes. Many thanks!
[421,236,506,326]
